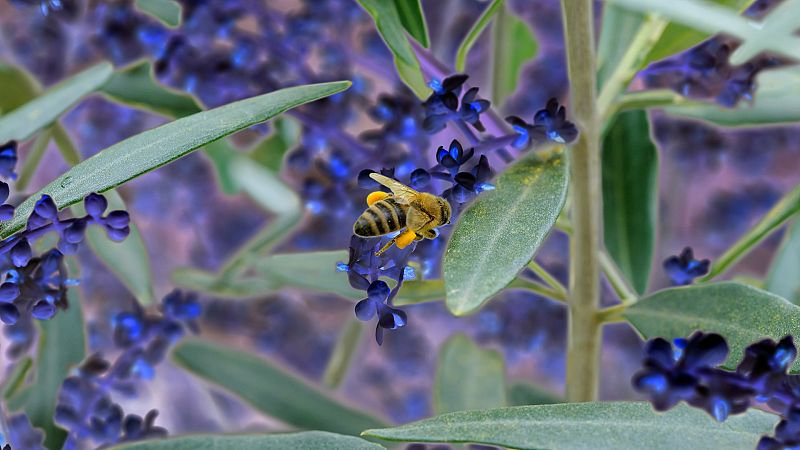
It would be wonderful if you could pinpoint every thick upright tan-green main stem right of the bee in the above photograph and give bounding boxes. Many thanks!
[561,0,602,402]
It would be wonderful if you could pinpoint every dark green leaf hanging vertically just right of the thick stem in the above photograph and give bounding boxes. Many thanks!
[602,111,658,294]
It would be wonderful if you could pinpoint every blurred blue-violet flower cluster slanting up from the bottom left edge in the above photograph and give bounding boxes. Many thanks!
[55,291,201,449]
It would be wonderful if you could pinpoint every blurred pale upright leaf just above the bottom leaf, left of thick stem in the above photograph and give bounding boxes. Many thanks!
[433,334,506,414]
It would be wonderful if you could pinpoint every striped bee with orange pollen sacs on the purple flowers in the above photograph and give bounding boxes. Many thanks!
[353,173,451,256]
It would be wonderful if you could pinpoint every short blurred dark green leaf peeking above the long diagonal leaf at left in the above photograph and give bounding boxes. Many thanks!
[102,61,202,119]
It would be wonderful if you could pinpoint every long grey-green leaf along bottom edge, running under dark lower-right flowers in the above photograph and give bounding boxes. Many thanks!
[364,402,778,450]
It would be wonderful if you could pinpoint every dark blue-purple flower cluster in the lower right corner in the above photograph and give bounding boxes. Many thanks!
[633,331,800,450]
